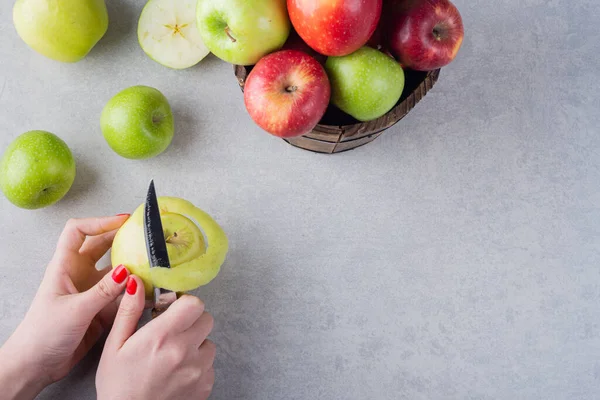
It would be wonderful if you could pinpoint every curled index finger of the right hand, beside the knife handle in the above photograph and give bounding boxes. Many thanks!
[148,294,204,334]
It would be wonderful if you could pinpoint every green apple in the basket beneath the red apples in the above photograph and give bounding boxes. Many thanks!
[325,46,404,121]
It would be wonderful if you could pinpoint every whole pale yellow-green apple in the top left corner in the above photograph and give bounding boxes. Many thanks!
[13,0,108,63]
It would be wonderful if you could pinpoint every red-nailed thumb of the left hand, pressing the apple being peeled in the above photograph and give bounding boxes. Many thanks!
[76,265,129,320]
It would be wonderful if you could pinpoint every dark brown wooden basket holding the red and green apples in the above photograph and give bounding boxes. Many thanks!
[234,65,440,154]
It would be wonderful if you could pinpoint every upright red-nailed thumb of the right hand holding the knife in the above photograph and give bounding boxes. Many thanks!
[106,275,145,350]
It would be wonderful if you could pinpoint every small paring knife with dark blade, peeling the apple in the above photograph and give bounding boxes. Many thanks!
[144,180,177,319]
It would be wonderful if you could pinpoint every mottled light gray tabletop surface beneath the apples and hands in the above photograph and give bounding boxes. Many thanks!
[0,0,600,400]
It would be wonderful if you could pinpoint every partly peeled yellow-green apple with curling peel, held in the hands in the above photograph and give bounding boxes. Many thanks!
[111,197,229,297]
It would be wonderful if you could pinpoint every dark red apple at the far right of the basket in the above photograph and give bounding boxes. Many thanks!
[387,0,464,71]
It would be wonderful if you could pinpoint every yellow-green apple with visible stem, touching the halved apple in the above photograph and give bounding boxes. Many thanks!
[197,0,291,65]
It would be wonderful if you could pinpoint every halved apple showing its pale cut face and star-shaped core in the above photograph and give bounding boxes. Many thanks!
[138,0,210,69]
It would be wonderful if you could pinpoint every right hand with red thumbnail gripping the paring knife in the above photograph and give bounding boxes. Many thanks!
[96,275,216,400]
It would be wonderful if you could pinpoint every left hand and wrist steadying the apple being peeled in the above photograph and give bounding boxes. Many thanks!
[0,215,129,399]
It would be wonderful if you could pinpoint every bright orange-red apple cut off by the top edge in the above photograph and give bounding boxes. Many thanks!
[287,0,382,56]
